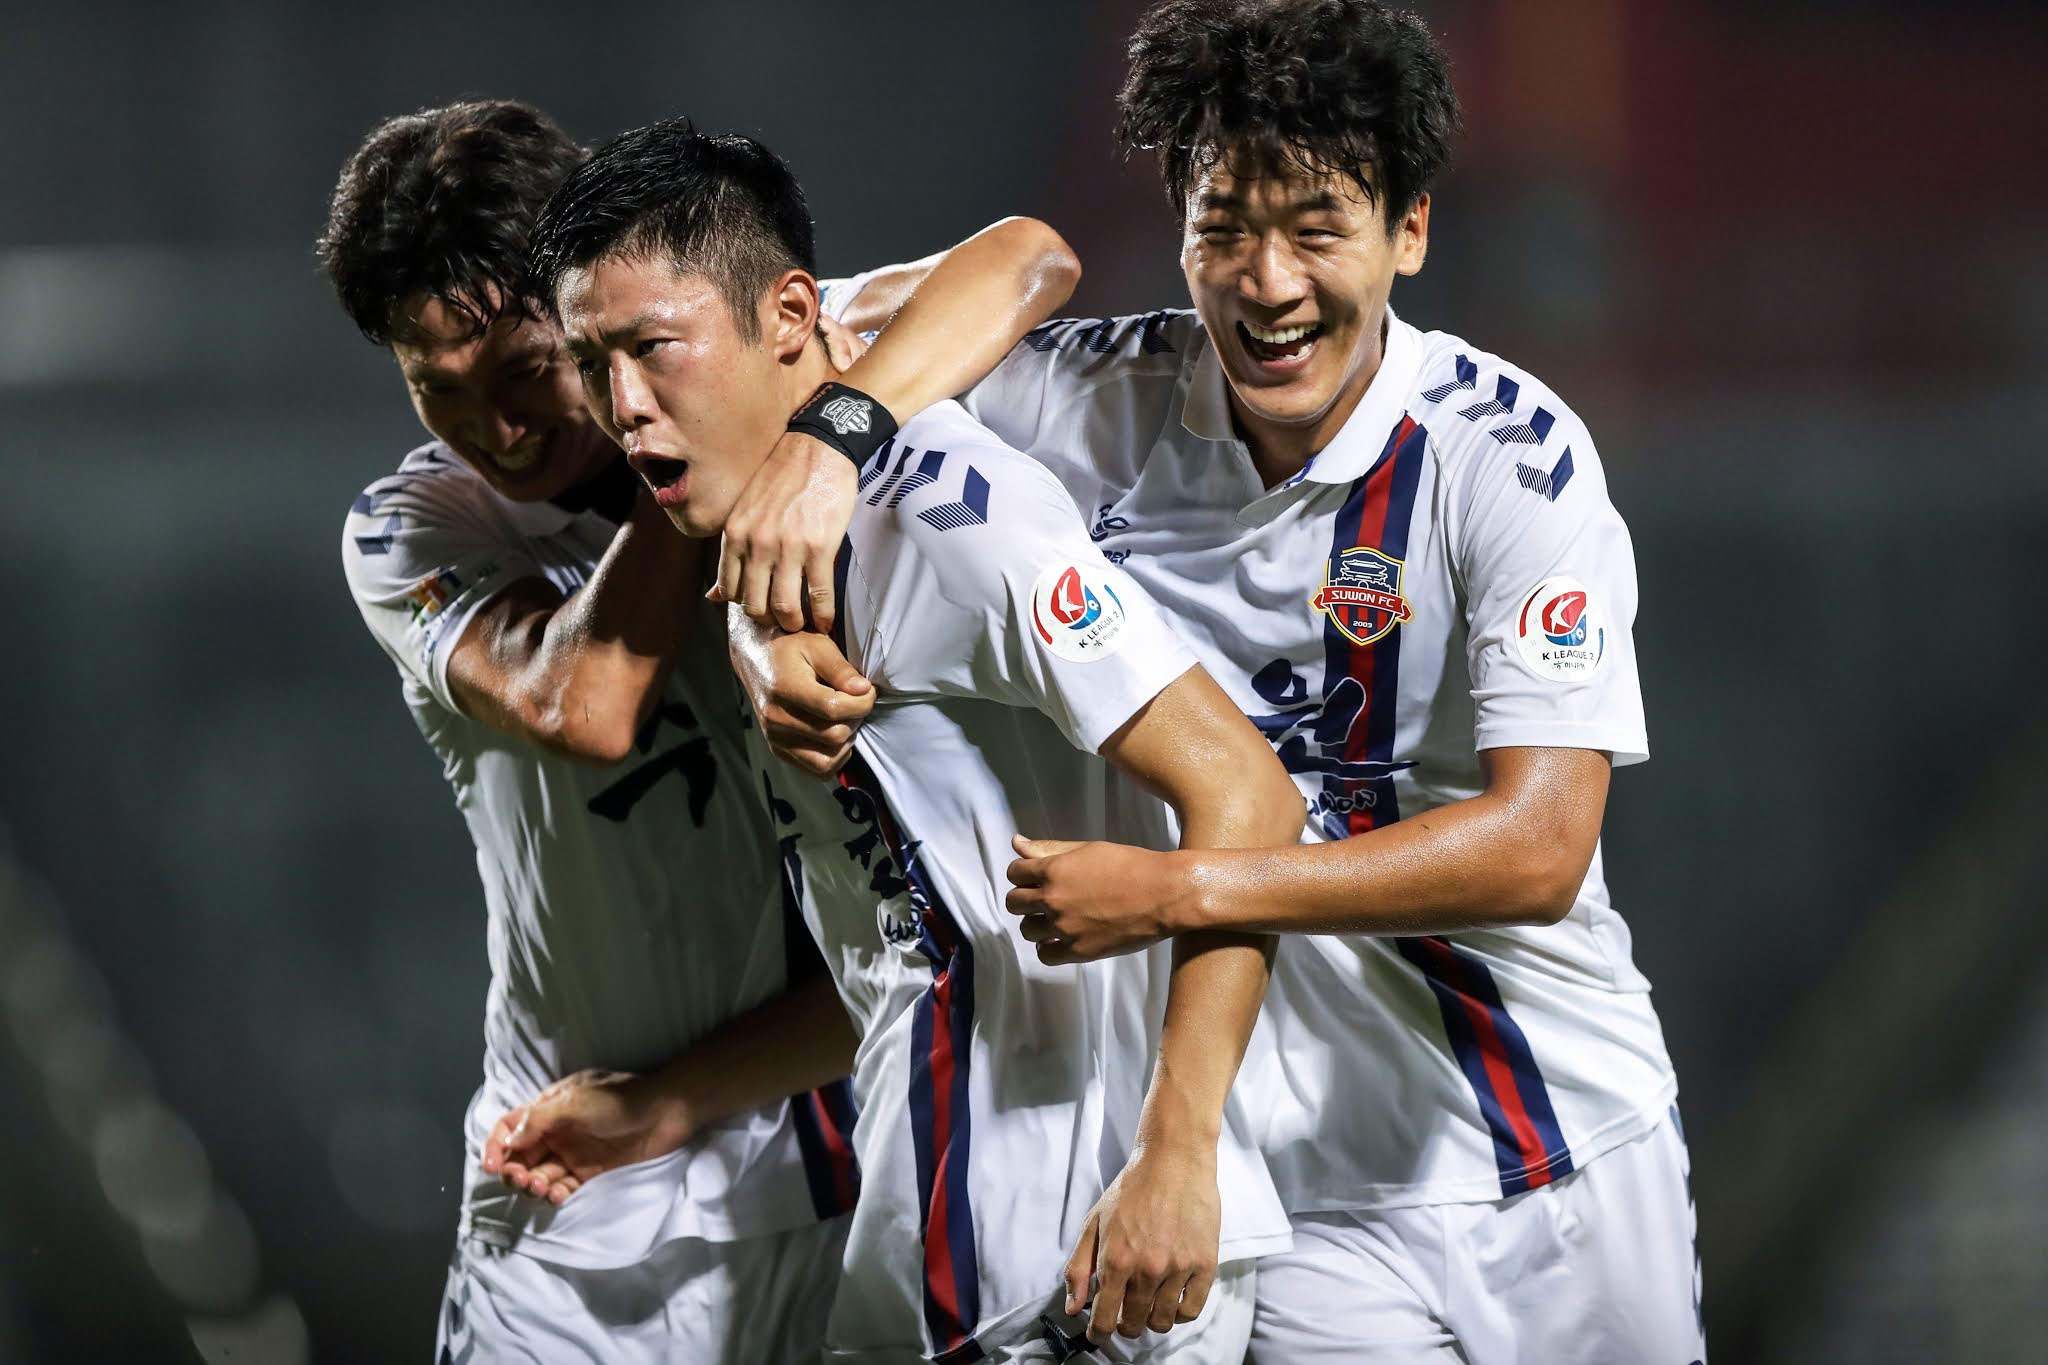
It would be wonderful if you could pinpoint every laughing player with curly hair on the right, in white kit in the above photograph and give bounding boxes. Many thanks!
[729,0,1704,1365]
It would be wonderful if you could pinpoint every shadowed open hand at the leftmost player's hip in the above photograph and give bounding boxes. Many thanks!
[483,1070,690,1205]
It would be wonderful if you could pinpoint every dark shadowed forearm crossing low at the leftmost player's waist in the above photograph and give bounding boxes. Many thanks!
[655,972,858,1136]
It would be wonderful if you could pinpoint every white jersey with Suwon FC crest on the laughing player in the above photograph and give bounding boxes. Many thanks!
[967,313,1677,1212]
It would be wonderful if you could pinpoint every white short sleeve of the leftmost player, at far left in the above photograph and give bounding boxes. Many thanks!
[342,471,541,712]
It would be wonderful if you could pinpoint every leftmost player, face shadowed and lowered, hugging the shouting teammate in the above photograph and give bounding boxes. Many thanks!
[319,100,1071,1365]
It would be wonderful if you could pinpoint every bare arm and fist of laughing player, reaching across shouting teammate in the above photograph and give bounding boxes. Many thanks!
[1010,747,1610,960]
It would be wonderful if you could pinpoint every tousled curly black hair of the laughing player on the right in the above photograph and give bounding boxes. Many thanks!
[1116,0,1460,231]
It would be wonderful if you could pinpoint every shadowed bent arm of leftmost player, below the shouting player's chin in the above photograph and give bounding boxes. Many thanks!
[449,481,707,763]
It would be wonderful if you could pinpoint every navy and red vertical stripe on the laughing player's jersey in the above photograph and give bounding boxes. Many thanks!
[1323,415,1571,1195]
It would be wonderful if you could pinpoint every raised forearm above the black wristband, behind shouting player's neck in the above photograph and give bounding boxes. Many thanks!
[842,219,1081,422]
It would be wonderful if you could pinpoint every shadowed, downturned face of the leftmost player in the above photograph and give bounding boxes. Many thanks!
[391,295,616,501]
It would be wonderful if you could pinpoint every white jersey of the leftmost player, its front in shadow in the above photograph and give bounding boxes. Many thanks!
[342,444,852,1269]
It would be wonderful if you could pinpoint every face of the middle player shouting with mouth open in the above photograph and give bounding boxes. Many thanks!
[555,258,815,536]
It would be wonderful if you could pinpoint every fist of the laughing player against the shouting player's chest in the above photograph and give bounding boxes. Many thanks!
[1004,835,1194,966]
